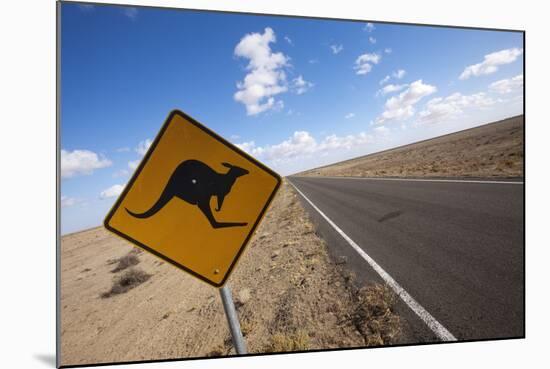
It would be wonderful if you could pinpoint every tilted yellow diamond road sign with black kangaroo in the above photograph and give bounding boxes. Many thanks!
[104,111,281,287]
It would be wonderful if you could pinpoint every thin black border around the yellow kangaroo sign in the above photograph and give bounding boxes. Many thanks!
[103,109,282,288]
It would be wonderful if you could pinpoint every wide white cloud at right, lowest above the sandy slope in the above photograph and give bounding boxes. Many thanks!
[418,92,496,123]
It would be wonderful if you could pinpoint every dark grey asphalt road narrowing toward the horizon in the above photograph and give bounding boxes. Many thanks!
[288,177,524,342]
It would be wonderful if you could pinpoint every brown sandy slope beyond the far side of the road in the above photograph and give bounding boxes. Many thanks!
[297,116,524,178]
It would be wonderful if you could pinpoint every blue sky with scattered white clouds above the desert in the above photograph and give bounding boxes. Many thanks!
[61,3,523,233]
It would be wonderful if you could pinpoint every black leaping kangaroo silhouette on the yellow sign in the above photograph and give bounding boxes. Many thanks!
[126,159,249,228]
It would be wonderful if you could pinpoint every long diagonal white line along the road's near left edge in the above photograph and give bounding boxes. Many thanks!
[289,181,457,341]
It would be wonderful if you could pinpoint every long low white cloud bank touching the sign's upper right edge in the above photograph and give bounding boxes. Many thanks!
[237,131,373,163]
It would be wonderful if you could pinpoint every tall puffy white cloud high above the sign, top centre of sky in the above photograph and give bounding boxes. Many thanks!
[233,28,289,115]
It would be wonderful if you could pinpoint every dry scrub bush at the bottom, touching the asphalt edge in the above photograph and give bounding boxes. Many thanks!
[350,284,401,346]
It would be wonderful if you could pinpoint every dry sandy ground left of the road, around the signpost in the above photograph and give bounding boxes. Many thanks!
[61,183,403,365]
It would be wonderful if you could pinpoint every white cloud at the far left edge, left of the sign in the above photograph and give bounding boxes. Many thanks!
[61,150,112,178]
